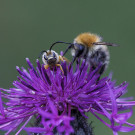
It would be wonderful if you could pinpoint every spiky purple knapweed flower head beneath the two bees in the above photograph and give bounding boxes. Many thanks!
[0,58,135,135]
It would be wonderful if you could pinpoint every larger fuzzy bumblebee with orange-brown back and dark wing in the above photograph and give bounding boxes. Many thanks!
[49,33,117,74]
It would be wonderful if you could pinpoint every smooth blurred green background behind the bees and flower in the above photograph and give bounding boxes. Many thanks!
[0,0,135,135]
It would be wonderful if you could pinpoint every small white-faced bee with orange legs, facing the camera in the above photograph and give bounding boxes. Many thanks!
[39,49,64,73]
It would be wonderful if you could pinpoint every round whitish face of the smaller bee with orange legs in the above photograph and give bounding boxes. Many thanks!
[42,50,59,65]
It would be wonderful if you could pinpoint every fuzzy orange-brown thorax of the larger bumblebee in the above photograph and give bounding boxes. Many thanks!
[74,33,101,47]
